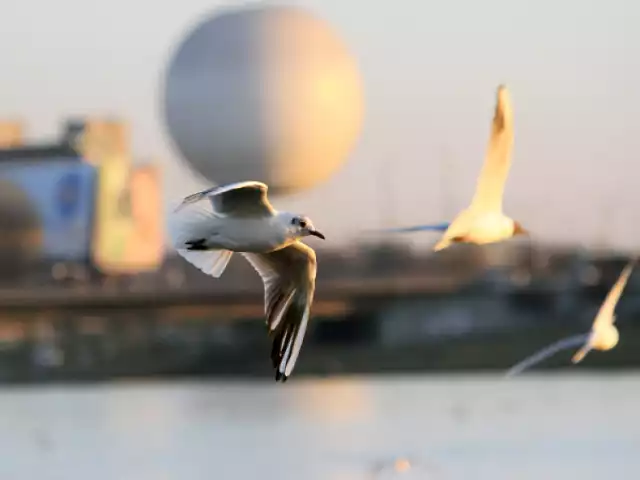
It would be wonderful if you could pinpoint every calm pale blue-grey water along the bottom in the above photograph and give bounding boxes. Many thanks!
[0,374,640,480]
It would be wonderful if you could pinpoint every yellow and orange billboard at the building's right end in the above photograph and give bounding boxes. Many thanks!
[92,156,164,275]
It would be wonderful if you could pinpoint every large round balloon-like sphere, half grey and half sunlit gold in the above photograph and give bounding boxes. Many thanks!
[164,6,363,194]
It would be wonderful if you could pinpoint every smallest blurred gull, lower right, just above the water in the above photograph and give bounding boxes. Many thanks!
[507,258,636,377]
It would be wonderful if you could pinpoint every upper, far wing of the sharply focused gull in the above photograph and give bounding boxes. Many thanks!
[176,181,274,217]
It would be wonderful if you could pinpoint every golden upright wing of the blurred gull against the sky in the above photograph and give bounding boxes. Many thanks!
[471,85,513,212]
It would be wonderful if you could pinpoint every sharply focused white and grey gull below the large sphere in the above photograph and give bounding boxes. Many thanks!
[170,181,325,382]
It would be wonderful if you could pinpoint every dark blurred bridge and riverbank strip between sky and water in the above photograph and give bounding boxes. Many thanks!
[0,244,640,381]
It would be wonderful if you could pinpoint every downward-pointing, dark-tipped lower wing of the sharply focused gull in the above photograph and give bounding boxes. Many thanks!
[242,242,316,382]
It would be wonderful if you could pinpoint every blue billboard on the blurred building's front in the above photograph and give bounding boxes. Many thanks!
[0,158,96,261]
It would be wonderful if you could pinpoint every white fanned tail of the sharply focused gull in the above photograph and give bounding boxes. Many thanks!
[169,197,233,277]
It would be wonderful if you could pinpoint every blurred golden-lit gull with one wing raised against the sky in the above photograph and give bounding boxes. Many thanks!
[386,85,528,252]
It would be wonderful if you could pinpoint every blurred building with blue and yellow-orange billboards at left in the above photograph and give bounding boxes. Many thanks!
[0,118,164,286]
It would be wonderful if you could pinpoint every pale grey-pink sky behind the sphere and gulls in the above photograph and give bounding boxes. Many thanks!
[0,0,640,248]
